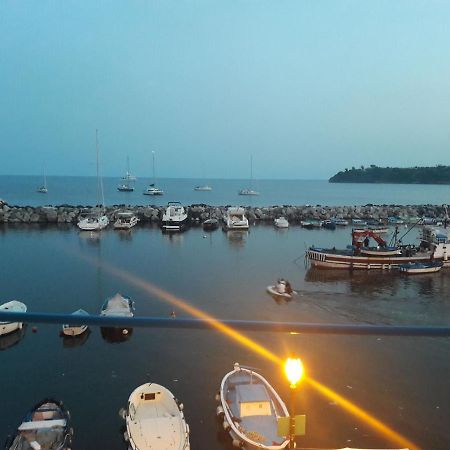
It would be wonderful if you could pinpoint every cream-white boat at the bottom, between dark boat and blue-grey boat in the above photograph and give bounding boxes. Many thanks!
[123,383,190,450]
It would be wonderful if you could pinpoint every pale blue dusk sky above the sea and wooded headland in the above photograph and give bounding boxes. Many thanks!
[0,0,450,179]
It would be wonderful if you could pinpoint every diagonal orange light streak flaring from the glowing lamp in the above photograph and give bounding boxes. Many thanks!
[68,250,420,450]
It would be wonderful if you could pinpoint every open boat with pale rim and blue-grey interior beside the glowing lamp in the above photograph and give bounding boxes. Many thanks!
[216,363,289,450]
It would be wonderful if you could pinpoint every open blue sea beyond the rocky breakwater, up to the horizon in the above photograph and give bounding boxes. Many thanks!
[0,176,450,206]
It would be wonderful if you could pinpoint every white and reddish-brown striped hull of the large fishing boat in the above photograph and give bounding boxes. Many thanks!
[306,249,450,270]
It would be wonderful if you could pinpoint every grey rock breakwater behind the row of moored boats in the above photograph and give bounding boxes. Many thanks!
[0,200,444,224]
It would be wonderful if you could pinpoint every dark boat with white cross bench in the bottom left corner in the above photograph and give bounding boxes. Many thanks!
[5,398,73,450]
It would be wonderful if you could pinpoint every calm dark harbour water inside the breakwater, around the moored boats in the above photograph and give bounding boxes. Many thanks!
[0,226,450,450]
